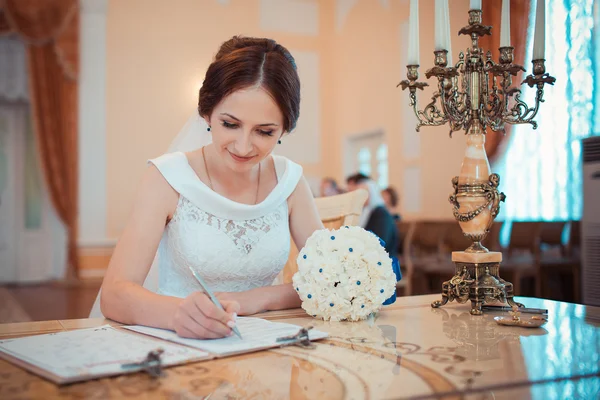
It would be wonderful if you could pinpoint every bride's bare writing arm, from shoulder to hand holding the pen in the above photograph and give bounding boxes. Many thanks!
[100,166,236,337]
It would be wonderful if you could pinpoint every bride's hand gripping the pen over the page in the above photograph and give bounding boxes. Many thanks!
[170,292,240,339]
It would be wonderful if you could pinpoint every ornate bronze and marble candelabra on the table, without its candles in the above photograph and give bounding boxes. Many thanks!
[398,10,555,315]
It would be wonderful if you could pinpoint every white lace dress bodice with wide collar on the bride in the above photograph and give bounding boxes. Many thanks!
[150,153,302,297]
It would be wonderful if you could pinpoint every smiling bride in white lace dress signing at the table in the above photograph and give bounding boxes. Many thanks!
[100,37,323,338]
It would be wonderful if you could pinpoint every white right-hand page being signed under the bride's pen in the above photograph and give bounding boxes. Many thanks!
[124,317,327,356]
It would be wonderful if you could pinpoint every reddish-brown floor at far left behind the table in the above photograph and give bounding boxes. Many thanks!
[0,280,101,323]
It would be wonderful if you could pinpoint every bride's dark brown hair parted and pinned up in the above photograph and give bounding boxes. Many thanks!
[198,36,300,132]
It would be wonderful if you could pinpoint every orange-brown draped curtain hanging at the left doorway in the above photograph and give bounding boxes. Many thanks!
[0,0,79,279]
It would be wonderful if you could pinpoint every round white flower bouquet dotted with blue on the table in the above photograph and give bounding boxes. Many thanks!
[293,226,396,321]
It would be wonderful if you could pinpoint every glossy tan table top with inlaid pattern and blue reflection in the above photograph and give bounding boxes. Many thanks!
[0,295,600,400]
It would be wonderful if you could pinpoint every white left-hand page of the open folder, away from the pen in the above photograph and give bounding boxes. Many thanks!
[0,325,209,381]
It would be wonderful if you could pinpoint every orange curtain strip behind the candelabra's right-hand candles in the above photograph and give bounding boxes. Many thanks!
[479,0,531,161]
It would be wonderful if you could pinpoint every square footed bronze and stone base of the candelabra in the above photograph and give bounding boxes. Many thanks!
[431,251,523,315]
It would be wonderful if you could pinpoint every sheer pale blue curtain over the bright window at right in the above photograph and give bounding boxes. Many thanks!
[494,0,600,220]
